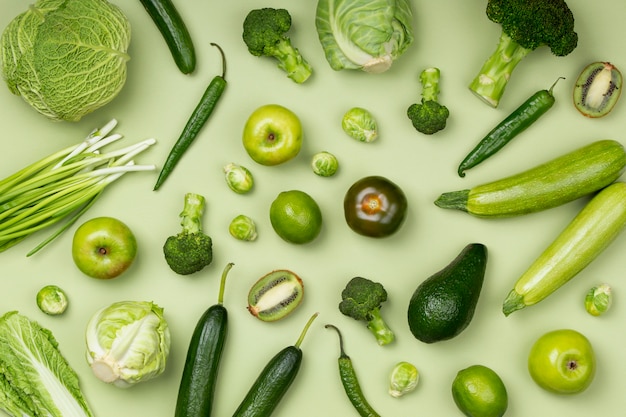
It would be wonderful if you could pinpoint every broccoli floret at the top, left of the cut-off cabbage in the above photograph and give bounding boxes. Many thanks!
[243,7,312,84]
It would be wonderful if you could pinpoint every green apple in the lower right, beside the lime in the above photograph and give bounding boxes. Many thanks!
[528,329,596,394]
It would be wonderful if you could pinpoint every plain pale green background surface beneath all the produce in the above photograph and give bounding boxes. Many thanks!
[0,0,626,417]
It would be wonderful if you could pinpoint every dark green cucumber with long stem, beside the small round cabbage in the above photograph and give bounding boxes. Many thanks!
[174,263,233,417]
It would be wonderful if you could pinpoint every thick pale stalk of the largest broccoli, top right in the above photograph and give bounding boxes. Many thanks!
[469,32,532,108]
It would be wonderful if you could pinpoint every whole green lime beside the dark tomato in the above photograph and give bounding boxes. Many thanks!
[270,190,322,244]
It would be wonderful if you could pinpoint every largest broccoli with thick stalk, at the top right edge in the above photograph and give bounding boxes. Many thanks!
[469,0,578,107]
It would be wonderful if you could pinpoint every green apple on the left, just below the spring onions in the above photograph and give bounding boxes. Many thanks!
[72,217,137,279]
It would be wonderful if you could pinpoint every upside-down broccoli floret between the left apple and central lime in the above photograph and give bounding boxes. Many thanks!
[163,193,213,275]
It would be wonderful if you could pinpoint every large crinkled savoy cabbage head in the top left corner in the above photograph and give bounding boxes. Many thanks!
[0,0,130,121]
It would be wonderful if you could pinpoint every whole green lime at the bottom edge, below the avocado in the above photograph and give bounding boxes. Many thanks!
[452,365,509,417]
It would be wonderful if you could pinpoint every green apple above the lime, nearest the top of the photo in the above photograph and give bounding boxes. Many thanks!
[243,104,302,166]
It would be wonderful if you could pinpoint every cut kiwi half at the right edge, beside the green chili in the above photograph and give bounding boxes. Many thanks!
[574,62,622,118]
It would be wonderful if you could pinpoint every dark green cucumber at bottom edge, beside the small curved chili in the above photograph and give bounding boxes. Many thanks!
[233,313,317,417]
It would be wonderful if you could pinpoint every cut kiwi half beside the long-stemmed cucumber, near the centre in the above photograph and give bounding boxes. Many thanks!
[248,269,304,321]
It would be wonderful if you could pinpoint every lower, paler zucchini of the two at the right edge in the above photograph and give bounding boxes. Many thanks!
[502,182,626,316]
